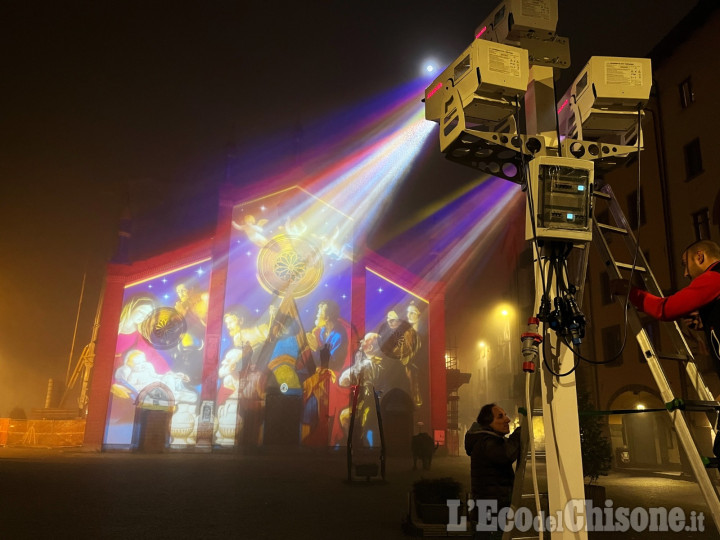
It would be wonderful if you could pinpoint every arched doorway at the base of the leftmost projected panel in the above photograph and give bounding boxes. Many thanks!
[133,382,175,453]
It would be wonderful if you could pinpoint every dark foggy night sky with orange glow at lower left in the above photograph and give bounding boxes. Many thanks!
[0,0,695,416]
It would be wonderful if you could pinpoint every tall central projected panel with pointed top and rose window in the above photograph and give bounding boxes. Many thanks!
[218,188,357,446]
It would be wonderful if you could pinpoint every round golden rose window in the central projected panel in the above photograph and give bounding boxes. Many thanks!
[257,234,324,298]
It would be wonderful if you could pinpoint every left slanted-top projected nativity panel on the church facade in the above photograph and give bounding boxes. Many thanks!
[104,260,211,448]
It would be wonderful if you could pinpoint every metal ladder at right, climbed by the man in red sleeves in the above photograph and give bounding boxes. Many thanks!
[593,185,720,530]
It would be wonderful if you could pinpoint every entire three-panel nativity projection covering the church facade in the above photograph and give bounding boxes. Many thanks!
[94,187,444,450]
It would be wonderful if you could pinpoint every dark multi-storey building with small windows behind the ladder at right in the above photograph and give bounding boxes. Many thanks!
[581,1,720,467]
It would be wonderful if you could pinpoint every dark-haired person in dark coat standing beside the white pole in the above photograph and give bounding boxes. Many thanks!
[465,403,520,538]
